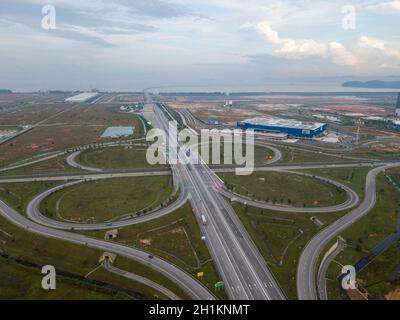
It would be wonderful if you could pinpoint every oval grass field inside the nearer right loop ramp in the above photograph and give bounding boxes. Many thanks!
[220,172,346,207]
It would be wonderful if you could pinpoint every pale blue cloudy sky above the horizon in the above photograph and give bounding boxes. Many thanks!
[0,0,400,91]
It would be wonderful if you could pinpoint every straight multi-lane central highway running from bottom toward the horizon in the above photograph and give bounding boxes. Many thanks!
[145,92,285,300]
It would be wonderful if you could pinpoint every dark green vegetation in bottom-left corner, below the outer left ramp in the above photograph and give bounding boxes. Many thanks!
[0,183,188,299]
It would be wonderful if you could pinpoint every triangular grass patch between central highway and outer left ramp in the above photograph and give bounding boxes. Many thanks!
[84,204,226,299]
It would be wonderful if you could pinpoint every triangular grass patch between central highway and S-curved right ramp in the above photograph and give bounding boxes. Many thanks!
[233,203,343,299]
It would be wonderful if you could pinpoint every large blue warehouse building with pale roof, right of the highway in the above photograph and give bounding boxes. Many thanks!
[237,118,327,139]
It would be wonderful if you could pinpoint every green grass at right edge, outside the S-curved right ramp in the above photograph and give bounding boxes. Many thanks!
[327,169,400,299]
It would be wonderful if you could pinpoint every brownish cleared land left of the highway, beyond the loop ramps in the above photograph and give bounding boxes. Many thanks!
[0,105,144,166]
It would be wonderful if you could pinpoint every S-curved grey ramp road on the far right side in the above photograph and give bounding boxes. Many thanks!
[296,163,400,300]
